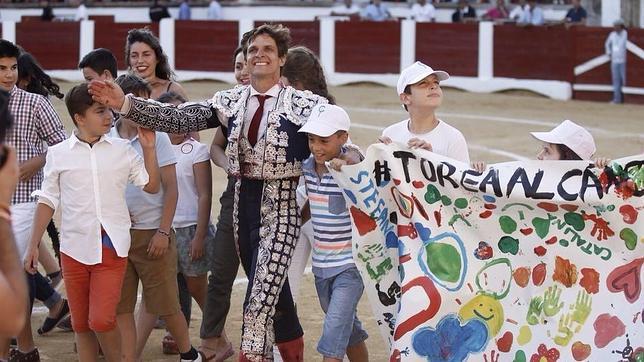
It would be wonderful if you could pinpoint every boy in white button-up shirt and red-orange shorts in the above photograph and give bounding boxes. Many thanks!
[25,84,160,361]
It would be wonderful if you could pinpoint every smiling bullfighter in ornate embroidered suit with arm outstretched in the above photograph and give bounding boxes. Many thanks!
[90,25,327,361]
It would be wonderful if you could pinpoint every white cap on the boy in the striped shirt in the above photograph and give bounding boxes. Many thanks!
[298,104,351,137]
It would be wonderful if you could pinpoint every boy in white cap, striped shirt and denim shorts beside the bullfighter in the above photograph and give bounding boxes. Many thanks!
[298,104,368,361]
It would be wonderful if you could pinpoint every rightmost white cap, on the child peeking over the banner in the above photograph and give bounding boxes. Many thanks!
[530,120,596,160]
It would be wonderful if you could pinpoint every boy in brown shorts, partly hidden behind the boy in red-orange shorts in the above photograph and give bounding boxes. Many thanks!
[110,74,201,361]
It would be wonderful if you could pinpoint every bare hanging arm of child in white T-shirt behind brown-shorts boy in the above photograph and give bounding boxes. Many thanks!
[190,161,212,261]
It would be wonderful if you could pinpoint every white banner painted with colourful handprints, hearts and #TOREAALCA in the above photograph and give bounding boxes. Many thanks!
[334,144,644,362]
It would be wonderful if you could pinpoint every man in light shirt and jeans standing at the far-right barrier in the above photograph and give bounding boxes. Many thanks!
[604,19,628,103]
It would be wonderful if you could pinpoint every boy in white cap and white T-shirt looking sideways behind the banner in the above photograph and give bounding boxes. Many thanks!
[380,62,470,164]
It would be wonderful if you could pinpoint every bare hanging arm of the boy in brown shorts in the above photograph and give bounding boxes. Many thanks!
[148,163,179,258]
